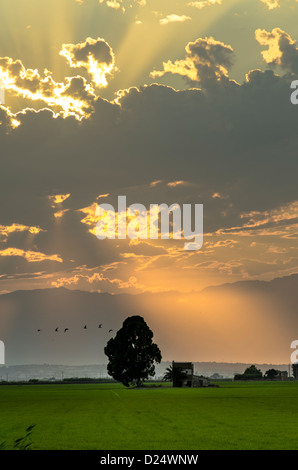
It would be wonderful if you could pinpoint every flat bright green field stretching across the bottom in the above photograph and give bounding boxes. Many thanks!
[0,382,298,450]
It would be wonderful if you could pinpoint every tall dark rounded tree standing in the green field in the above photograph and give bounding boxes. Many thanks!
[104,315,161,387]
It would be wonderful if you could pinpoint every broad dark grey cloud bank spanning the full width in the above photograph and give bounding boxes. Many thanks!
[1,71,296,218]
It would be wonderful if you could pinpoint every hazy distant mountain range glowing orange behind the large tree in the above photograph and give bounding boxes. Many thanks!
[0,274,298,366]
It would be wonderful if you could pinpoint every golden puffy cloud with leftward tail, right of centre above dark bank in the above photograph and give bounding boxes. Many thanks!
[151,37,234,86]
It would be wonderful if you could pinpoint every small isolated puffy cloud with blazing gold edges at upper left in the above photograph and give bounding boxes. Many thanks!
[60,38,115,87]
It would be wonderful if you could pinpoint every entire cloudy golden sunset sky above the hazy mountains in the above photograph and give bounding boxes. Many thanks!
[0,0,298,359]
